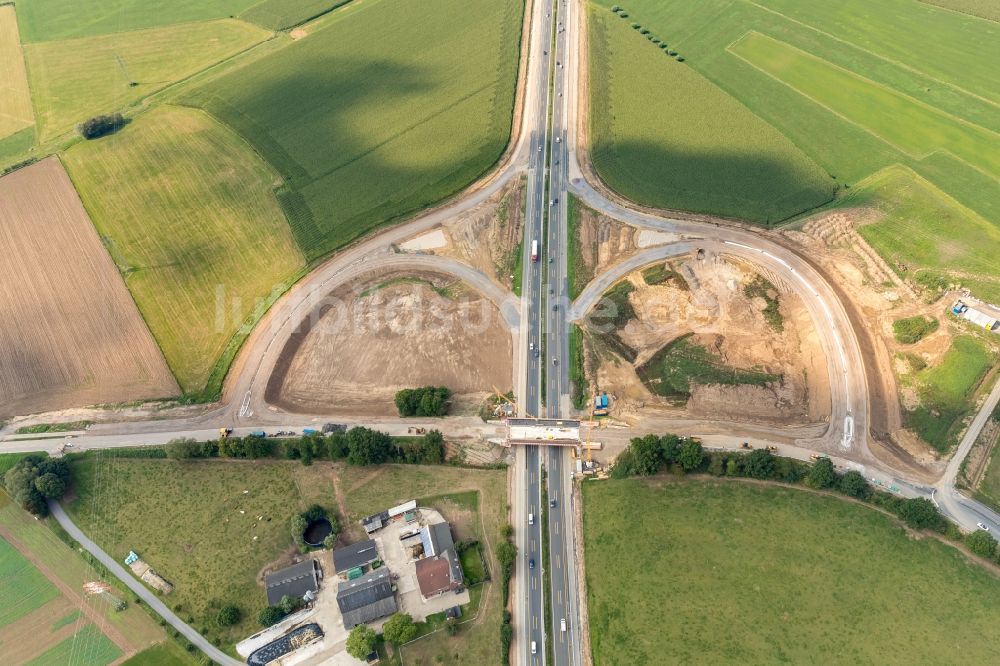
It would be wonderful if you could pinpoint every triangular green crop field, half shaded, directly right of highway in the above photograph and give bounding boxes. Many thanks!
[590,9,835,224]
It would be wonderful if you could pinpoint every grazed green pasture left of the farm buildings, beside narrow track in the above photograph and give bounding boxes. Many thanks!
[67,455,304,647]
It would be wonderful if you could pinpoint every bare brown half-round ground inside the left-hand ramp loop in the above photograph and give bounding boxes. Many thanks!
[267,274,512,416]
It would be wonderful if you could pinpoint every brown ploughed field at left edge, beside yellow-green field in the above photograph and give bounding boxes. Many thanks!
[0,158,177,416]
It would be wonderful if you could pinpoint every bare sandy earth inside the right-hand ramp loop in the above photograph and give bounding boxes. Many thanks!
[587,255,830,424]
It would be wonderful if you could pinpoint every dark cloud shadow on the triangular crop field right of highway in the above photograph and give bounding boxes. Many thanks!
[591,141,839,226]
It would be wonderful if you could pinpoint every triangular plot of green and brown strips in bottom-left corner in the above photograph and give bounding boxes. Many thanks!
[0,491,166,666]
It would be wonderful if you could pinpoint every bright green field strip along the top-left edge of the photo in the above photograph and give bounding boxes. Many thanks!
[17,0,260,42]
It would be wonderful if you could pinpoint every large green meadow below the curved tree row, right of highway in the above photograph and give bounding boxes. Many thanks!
[583,479,1000,665]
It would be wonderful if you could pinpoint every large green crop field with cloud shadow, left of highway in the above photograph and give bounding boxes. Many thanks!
[185,0,523,258]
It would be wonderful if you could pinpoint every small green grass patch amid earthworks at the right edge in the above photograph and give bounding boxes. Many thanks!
[905,335,996,453]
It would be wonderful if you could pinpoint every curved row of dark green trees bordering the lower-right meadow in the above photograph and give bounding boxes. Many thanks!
[610,434,1000,564]
